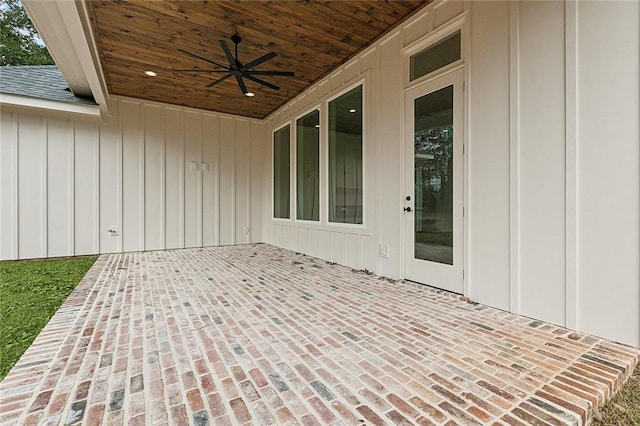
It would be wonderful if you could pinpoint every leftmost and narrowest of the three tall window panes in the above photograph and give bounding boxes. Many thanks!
[273,126,291,219]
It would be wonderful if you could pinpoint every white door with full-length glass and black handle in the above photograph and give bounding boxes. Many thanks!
[404,70,464,293]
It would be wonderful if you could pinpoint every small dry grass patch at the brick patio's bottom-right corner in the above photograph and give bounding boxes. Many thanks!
[592,366,640,426]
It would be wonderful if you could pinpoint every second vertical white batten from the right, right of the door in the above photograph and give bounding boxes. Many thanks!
[509,2,520,313]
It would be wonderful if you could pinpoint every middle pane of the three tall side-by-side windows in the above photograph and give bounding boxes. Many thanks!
[296,110,320,220]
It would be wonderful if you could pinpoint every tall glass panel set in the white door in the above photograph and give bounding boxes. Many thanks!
[413,86,453,265]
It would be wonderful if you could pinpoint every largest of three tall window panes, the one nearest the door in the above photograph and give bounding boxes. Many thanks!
[329,86,362,224]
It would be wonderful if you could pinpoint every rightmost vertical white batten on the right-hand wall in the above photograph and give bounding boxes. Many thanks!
[565,0,579,329]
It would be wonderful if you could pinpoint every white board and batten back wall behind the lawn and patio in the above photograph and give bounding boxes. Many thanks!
[0,97,267,260]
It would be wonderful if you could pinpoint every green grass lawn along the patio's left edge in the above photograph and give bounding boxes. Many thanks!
[0,257,96,380]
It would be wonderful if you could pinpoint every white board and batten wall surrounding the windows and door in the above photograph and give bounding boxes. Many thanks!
[264,0,640,346]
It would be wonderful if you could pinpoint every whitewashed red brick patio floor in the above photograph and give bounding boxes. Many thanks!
[0,244,639,425]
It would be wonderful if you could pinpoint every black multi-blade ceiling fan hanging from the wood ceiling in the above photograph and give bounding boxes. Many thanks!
[177,34,294,96]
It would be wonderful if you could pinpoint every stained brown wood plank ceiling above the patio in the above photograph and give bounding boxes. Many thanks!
[87,0,429,118]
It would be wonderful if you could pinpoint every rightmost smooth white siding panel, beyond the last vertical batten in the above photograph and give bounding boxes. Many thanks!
[568,1,640,346]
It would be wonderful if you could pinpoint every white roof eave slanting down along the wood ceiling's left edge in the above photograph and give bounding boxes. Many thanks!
[22,0,109,115]
